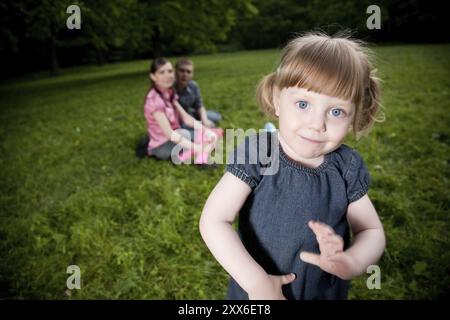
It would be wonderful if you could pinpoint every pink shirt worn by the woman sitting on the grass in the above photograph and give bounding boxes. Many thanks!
[144,88,180,150]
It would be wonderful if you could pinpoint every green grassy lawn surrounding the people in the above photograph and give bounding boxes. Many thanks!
[0,45,450,299]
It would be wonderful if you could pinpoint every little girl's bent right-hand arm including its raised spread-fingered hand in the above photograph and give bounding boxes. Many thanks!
[300,194,386,280]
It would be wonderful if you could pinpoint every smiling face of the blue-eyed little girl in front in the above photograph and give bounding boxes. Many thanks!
[275,87,354,166]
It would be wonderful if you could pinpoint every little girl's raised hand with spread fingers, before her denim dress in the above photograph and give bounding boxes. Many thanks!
[300,221,356,280]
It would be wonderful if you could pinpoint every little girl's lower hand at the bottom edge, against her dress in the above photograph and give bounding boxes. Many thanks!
[248,273,295,300]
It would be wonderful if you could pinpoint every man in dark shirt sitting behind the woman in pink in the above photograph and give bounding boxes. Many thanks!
[175,58,222,128]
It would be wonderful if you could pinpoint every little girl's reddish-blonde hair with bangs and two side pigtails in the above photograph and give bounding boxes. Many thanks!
[256,32,382,138]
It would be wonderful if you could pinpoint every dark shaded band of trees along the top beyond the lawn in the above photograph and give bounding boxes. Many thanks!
[0,0,450,78]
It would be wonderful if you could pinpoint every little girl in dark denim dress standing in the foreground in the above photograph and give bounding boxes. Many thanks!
[200,33,385,299]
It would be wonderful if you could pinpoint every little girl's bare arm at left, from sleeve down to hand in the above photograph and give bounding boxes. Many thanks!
[200,172,294,299]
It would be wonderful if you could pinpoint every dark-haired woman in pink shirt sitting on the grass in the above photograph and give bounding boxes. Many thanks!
[144,58,215,160]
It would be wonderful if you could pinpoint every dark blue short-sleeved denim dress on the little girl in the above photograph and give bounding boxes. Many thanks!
[225,132,370,300]
